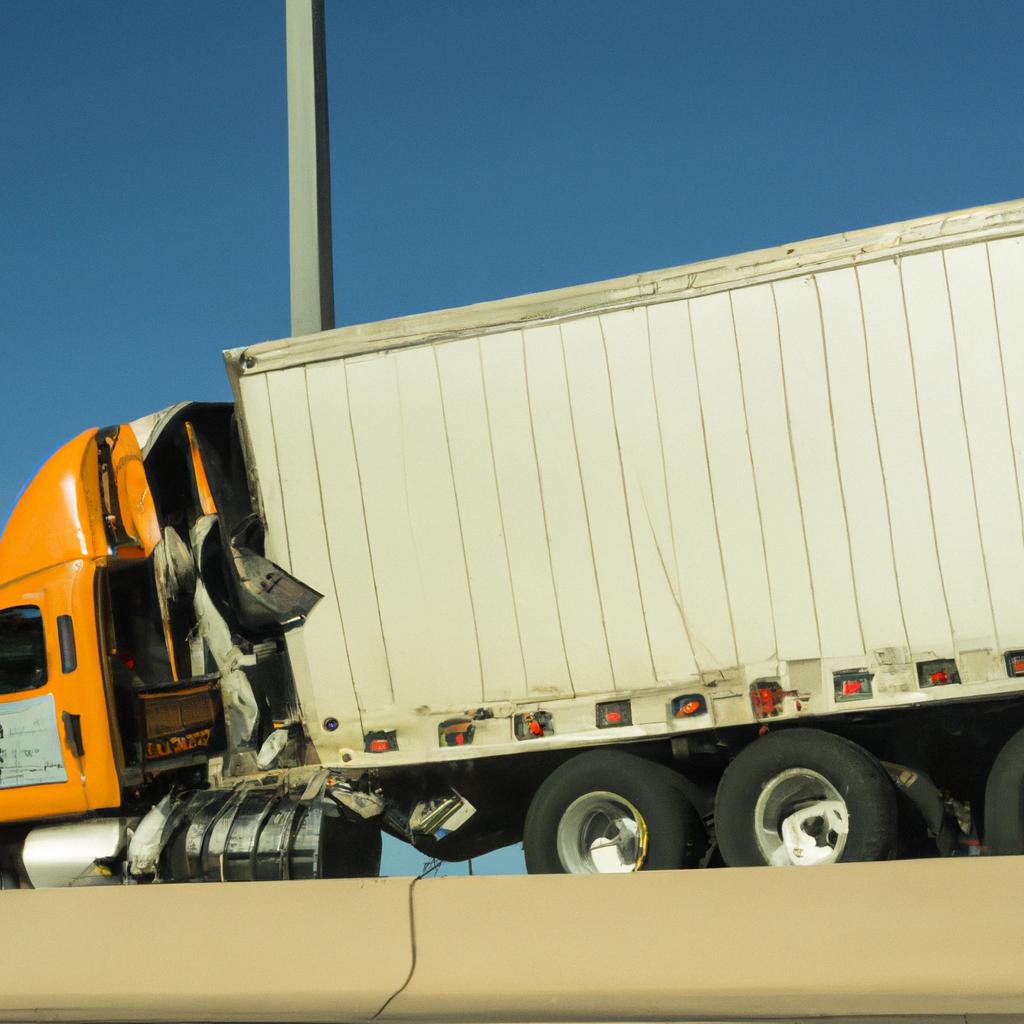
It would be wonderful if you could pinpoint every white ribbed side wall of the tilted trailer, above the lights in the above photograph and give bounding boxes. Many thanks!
[239,218,1024,761]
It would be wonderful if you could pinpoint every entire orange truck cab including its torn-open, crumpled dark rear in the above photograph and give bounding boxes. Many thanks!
[0,403,360,886]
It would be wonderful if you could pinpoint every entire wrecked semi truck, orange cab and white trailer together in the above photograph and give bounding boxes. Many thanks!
[6,195,1024,887]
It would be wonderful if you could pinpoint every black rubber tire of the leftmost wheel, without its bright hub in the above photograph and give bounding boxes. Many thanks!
[522,751,708,874]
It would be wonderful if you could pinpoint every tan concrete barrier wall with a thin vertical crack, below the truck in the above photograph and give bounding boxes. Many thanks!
[0,858,1024,1024]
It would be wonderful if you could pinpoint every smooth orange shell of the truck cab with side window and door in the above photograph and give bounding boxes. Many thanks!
[0,431,125,822]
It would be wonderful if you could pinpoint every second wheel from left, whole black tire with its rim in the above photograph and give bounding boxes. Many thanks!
[715,729,898,866]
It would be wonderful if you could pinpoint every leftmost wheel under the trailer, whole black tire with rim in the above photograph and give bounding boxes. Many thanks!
[523,751,708,874]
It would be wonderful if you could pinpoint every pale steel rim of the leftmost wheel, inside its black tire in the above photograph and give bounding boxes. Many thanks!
[555,791,647,874]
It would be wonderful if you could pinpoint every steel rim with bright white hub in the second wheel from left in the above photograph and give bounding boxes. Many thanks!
[754,768,850,867]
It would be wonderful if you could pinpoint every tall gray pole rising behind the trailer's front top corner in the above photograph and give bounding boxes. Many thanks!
[285,0,334,336]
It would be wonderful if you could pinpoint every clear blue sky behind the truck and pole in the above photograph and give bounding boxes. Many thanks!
[0,0,1024,870]
